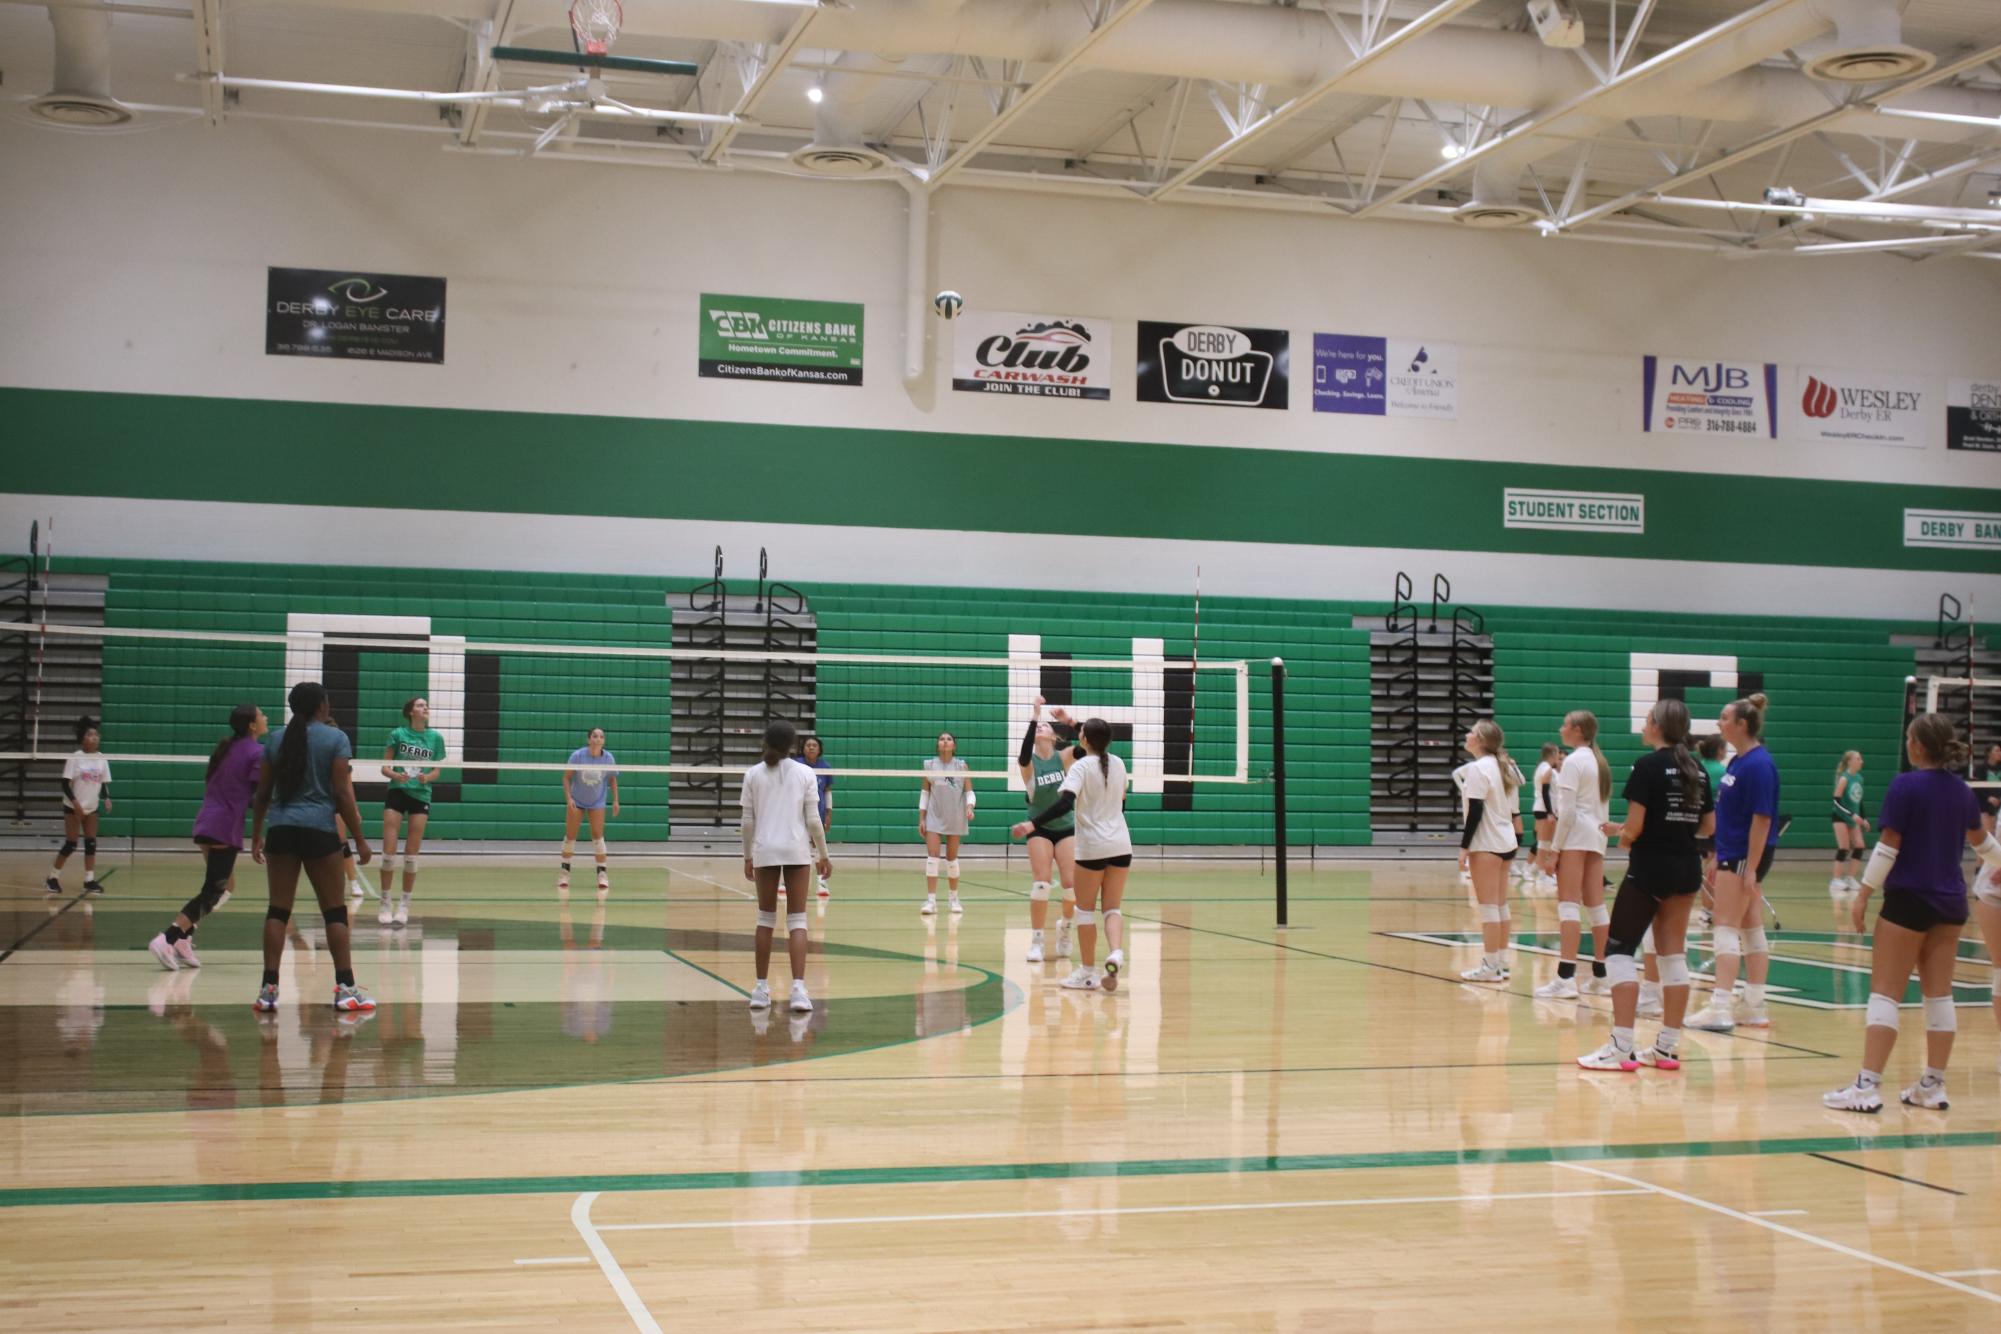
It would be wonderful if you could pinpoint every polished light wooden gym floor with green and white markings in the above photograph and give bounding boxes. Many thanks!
[0,852,2001,1330]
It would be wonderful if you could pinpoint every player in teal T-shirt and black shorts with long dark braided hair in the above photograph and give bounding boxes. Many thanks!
[250,680,374,1012]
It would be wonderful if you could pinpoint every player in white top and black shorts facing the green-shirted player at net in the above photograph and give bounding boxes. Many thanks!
[1011,718,1133,992]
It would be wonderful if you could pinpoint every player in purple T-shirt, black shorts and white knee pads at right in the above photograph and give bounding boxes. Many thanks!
[1821,714,2001,1112]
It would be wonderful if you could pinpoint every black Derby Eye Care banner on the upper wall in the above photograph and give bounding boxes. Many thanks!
[264,268,444,366]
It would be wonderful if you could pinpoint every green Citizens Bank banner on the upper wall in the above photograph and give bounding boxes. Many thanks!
[698,292,862,384]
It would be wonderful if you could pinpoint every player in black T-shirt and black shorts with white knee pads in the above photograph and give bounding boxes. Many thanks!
[1577,700,1717,1070]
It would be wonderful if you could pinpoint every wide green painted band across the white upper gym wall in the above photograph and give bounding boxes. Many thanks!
[15,388,2001,572]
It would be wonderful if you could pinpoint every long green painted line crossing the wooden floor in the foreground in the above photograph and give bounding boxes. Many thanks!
[0,1130,2001,1208]
